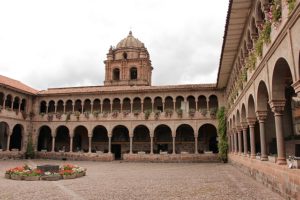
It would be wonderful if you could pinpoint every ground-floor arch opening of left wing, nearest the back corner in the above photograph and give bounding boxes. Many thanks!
[9,124,24,151]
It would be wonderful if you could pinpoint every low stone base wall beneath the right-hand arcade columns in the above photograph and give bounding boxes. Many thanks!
[229,154,300,200]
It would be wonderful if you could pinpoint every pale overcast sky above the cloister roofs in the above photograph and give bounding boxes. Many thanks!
[0,0,228,89]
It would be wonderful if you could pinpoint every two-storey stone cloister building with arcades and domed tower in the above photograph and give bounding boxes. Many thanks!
[0,0,300,198]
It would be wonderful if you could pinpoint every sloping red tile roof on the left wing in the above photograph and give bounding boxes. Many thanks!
[0,75,38,94]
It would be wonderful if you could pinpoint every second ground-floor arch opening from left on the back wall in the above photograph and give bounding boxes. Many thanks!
[55,125,70,152]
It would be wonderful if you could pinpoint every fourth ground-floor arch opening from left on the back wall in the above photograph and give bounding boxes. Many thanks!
[92,125,108,153]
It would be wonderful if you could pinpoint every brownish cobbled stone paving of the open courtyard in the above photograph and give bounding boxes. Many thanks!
[0,160,282,200]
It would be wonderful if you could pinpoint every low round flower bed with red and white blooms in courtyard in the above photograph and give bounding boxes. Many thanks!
[5,164,86,181]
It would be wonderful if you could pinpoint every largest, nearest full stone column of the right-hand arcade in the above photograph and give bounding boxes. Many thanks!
[270,100,286,165]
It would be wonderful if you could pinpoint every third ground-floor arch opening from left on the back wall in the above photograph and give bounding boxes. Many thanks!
[73,125,89,152]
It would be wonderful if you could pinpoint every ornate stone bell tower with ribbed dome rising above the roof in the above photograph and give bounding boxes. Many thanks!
[104,31,153,86]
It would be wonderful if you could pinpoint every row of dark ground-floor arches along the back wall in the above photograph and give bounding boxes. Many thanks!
[33,123,218,159]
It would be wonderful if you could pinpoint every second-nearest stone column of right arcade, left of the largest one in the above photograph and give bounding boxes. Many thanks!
[256,111,268,161]
